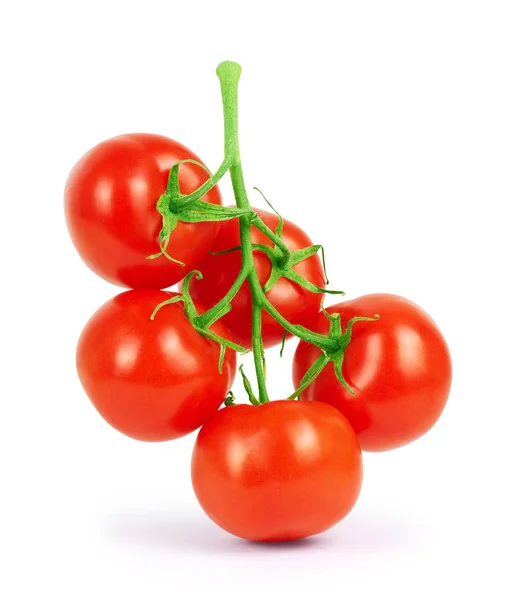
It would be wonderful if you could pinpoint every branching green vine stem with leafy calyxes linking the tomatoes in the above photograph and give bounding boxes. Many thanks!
[150,61,370,404]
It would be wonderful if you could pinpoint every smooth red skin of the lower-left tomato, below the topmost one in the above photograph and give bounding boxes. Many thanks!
[76,290,236,441]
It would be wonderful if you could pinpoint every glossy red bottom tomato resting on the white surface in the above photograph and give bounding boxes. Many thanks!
[191,400,362,542]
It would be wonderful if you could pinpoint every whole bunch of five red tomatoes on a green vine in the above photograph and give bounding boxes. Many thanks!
[65,61,452,541]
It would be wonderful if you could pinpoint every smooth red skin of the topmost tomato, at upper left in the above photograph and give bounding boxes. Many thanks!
[65,133,221,289]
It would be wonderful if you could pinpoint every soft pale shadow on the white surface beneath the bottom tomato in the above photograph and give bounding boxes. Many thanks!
[103,510,418,555]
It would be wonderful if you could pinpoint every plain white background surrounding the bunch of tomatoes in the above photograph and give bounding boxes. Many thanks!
[0,0,509,600]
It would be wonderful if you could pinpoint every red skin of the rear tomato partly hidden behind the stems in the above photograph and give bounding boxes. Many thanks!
[185,208,325,348]
